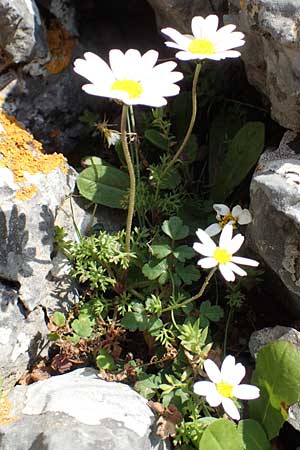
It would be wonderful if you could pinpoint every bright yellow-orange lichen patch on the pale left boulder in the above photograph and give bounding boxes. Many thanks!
[0,110,67,186]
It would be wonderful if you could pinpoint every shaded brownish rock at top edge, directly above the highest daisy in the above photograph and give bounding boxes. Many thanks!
[148,0,225,32]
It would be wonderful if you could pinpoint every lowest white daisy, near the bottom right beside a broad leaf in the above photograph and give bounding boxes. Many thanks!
[194,355,259,420]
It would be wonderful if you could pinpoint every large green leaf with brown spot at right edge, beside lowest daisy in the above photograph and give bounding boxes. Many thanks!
[249,341,300,439]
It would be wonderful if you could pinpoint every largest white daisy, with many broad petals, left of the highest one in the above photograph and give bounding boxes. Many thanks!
[74,49,183,107]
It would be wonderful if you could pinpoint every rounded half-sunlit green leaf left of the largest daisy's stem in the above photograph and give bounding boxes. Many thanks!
[77,165,129,208]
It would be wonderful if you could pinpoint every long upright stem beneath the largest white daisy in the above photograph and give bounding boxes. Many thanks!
[121,104,135,253]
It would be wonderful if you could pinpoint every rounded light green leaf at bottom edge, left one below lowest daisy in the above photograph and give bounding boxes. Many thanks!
[199,419,244,450]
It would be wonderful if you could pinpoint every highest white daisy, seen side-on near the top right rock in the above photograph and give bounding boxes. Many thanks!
[161,15,245,61]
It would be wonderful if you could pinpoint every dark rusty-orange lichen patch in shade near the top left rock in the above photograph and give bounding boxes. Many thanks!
[45,20,76,74]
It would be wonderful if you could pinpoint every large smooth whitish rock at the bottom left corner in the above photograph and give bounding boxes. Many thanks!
[0,368,166,450]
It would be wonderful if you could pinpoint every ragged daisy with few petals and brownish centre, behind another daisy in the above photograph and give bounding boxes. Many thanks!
[204,204,252,236]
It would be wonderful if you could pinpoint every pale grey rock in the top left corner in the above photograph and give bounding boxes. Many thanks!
[0,0,48,66]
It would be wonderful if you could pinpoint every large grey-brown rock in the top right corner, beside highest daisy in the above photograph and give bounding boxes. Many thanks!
[228,0,300,131]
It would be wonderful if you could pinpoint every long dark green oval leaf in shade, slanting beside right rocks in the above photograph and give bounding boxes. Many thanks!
[212,122,265,202]
